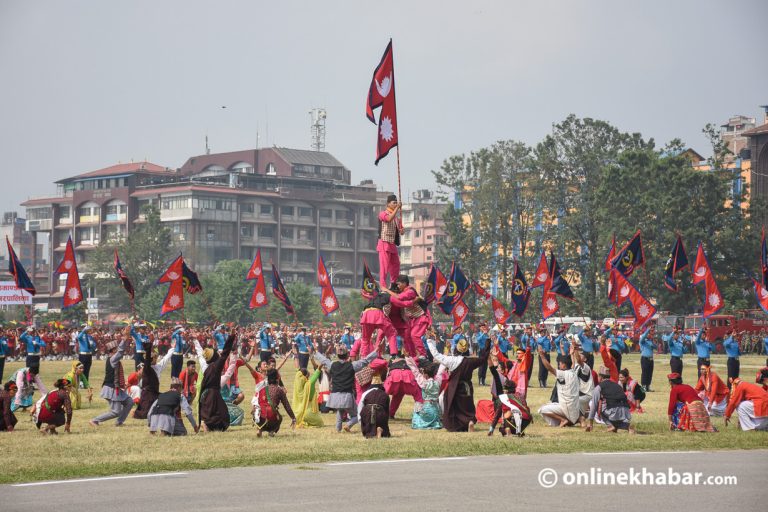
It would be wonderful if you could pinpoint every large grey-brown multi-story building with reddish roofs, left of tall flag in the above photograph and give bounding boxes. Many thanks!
[23,147,383,310]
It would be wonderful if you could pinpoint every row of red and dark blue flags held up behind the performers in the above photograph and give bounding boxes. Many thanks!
[6,230,768,330]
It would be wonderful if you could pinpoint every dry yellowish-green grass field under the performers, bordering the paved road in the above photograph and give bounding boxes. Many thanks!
[0,354,768,483]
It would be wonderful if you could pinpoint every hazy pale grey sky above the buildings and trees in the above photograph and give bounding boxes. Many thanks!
[0,0,768,211]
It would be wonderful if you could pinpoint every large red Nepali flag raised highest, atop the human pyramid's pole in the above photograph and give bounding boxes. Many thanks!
[365,39,398,165]
